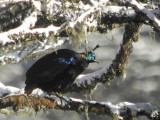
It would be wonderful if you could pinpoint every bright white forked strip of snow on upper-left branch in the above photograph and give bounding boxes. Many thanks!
[0,11,61,45]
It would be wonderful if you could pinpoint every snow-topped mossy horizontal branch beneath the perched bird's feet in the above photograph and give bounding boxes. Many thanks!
[0,95,160,120]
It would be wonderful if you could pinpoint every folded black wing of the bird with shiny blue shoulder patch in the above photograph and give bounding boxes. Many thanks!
[26,57,75,83]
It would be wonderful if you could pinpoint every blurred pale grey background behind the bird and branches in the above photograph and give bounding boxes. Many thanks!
[0,26,160,120]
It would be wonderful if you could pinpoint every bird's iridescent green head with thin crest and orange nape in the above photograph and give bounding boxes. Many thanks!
[81,45,100,63]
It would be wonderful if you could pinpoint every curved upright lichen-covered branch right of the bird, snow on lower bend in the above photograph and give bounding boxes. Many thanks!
[66,23,141,92]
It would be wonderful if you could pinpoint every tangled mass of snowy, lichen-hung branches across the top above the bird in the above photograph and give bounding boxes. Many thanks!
[0,0,160,64]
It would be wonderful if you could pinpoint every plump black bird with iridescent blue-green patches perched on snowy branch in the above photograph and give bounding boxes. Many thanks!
[25,45,99,94]
